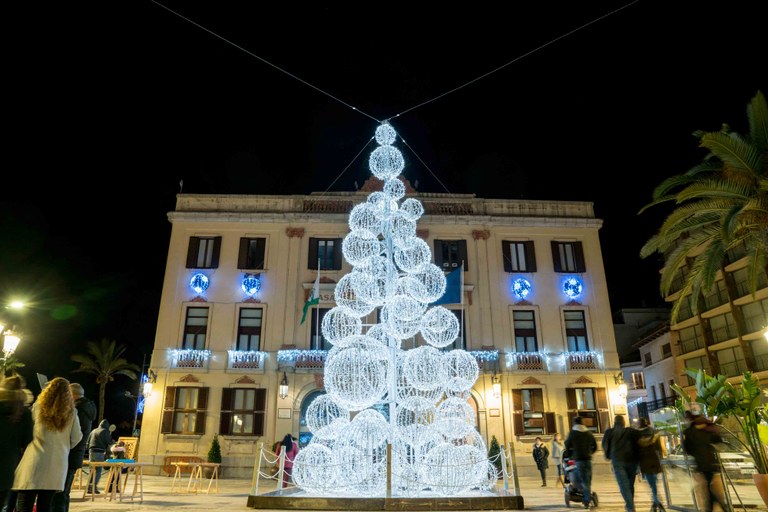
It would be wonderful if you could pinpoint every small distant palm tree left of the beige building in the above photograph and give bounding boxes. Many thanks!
[72,338,141,422]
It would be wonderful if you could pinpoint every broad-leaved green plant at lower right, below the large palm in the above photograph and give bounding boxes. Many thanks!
[672,368,768,475]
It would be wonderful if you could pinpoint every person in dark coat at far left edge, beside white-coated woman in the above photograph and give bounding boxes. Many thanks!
[0,375,32,510]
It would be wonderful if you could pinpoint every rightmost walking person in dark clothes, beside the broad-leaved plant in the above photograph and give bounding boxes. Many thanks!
[683,415,728,512]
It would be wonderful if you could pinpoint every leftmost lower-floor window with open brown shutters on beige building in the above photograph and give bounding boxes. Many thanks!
[161,386,208,434]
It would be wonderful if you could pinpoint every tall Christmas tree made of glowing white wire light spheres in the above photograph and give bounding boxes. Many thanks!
[294,123,498,496]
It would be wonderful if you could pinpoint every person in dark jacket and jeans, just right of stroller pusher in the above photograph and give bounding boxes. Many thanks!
[603,415,640,512]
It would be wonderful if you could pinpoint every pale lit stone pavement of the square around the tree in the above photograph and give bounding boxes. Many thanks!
[70,474,766,512]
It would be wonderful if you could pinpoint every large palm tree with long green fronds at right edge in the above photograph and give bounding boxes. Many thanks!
[639,91,768,322]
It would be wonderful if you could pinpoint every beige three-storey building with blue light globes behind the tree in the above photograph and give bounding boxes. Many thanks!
[139,179,626,476]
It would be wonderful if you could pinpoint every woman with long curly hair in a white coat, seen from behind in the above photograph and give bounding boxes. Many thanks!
[13,377,83,512]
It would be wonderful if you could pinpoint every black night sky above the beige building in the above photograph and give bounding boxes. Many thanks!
[0,0,767,424]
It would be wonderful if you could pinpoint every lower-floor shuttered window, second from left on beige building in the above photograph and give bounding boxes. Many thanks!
[219,388,267,436]
